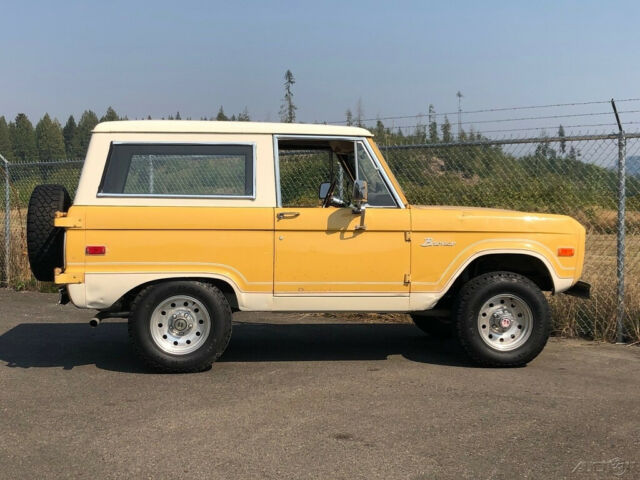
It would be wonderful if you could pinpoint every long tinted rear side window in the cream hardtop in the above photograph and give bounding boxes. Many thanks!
[98,143,255,198]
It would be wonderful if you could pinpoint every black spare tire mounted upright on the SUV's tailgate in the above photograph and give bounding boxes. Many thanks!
[27,185,71,282]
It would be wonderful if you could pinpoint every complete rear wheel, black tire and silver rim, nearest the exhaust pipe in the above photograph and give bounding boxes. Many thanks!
[129,281,231,373]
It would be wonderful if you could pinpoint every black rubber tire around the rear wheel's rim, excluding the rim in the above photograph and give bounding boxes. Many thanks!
[129,280,231,373]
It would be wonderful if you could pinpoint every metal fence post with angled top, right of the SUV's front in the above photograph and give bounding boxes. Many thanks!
[611,99,627,343]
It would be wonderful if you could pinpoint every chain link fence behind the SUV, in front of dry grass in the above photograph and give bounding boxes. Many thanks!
[0,134,640,341]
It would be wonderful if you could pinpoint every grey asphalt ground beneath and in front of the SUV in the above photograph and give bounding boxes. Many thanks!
[0,290,640,480]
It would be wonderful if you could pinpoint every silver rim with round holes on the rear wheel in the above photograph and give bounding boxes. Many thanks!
[149,295,211,355]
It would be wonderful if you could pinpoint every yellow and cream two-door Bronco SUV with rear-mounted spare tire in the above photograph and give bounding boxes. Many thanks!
[27,121,589,372]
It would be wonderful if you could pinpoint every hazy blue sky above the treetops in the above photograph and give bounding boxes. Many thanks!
[0,0,640,132]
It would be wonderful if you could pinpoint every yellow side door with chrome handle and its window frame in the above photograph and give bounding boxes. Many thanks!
[274,137,410,310]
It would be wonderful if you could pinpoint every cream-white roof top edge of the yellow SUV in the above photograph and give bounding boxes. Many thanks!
[93,120,372,137]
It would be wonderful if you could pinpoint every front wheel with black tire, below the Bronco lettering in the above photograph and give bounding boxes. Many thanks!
[454,272,551,367]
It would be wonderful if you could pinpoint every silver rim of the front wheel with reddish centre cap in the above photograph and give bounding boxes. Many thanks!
[478,294,533,352]
